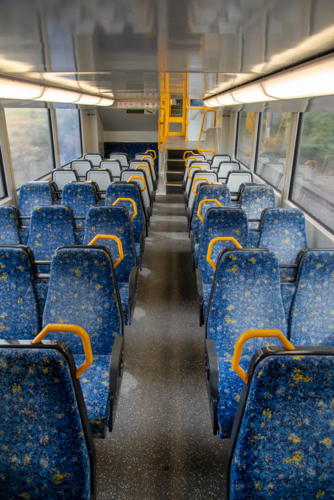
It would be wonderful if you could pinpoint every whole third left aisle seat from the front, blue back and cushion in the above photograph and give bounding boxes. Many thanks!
[84,205,138,325]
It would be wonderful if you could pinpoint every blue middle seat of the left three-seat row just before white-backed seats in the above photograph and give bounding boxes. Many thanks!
[62,182,97,245]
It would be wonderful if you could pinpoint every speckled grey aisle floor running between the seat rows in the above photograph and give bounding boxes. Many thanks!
[95,195,228,500]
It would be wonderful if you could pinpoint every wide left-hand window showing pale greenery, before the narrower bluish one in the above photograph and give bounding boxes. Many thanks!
[5,108,54,189]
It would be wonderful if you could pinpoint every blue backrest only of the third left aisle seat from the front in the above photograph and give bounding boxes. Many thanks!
[84,205,137,283]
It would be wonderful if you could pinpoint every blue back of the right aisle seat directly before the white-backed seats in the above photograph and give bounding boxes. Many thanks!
[191,183,232,244]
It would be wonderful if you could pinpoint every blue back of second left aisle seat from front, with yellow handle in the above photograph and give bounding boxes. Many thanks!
[43,246,123,354]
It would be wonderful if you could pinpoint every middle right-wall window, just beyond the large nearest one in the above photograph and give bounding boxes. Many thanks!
[255,111,291,191]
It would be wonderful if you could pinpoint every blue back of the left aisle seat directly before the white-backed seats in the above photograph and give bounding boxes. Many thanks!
[105,182,145,243]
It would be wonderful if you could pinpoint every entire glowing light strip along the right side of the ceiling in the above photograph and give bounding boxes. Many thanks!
[204,56,334,107]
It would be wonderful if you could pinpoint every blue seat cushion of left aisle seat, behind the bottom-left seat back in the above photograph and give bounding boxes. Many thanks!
[74,354,110,439]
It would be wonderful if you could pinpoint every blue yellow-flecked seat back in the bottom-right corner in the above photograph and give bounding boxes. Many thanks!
[230,353,334,500]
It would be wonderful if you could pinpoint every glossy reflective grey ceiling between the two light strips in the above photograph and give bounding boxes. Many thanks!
[0,0,334,100]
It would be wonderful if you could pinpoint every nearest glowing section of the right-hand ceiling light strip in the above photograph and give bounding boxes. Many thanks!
[262,57,334,99]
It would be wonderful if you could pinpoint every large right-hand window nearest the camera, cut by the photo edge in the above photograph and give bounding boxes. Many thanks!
[290,113,334,231]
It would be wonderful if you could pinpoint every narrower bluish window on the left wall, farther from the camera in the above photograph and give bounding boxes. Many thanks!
[56,109,82,165]
